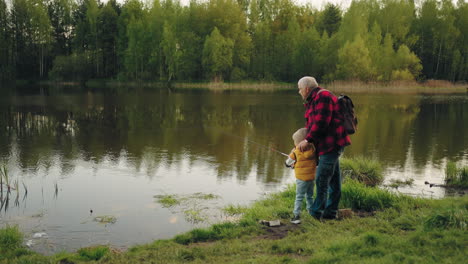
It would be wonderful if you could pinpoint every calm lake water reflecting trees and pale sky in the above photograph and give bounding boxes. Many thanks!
[0,86,468,254]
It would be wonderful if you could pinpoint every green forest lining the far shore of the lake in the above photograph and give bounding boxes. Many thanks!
[0,0,468,83]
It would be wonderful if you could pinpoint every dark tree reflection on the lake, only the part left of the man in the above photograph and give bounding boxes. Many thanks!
[0,93,299,185]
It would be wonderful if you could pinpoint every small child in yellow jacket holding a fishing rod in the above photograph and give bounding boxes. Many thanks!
[286,128,317,224]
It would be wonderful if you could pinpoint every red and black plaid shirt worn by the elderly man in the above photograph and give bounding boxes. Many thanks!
[304,87,351,156]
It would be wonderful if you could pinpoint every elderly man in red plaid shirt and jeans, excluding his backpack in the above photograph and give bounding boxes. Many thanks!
[297,76,351,219]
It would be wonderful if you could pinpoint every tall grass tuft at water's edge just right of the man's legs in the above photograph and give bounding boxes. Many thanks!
[340,157,384,186]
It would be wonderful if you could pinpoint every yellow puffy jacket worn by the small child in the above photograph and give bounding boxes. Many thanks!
[289,146,317,181]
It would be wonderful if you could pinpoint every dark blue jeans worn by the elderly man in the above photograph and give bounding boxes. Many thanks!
[311,148,344,218]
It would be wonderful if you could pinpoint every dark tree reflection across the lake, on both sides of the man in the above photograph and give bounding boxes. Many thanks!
[0,92,468,179]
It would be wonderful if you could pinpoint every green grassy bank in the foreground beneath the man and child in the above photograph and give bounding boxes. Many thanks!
[0,180,468,264]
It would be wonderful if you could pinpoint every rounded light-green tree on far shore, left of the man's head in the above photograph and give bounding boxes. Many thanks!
[203,27,234,81]
